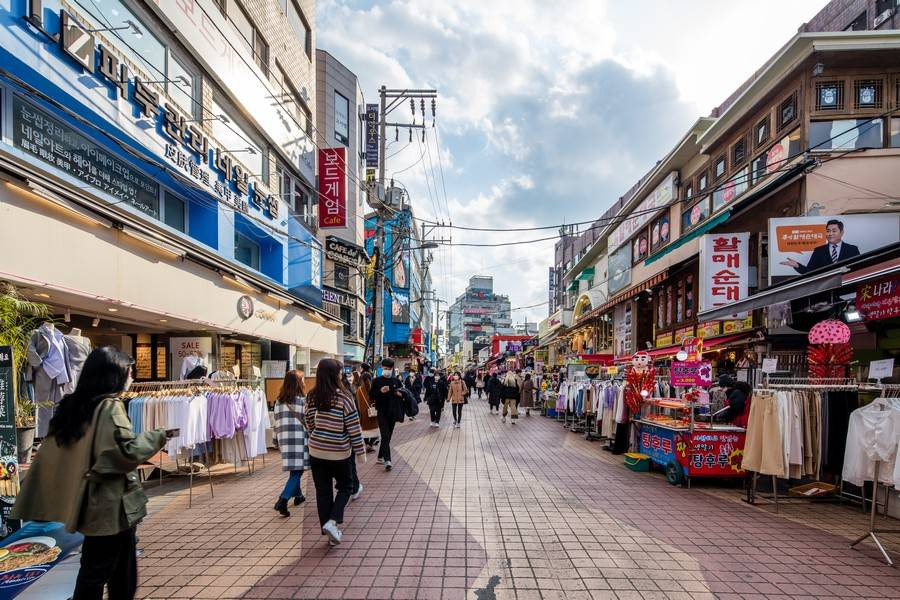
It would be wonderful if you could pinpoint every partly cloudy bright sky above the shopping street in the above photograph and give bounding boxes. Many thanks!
[316,0,826,330]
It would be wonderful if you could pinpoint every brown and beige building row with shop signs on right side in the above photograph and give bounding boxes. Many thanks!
[545,2,900,378]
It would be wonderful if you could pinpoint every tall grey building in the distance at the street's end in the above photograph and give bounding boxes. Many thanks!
[447,275,515,361]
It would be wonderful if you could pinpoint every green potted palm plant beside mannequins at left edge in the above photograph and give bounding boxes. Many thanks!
[0,283,50,464]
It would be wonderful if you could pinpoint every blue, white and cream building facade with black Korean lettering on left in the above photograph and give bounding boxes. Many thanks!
[0,0,340,380]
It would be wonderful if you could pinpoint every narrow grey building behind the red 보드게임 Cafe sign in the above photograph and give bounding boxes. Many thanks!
[316,49,368,363]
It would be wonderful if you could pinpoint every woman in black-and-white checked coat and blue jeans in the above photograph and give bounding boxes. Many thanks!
[275,370,309,517]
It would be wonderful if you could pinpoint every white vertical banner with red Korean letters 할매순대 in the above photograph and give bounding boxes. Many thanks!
[700,232,750,312]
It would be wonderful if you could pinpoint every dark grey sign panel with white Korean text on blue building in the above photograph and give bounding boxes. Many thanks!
[12,96,159,219]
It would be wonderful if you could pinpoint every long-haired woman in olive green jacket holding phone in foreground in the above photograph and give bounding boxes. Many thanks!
[11,347,172,600]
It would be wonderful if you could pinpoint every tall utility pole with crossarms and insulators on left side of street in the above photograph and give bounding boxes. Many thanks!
[372,86,437,365]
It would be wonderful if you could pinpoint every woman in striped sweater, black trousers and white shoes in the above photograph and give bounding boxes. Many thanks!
[306,358,366,546]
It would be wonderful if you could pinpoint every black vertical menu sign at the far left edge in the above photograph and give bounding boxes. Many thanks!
[0,346,19,537]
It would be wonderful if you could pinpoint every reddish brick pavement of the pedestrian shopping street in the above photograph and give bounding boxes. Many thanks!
[139,401,900,600]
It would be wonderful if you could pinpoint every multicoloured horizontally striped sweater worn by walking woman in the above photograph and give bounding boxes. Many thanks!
[306,393,366,460]
